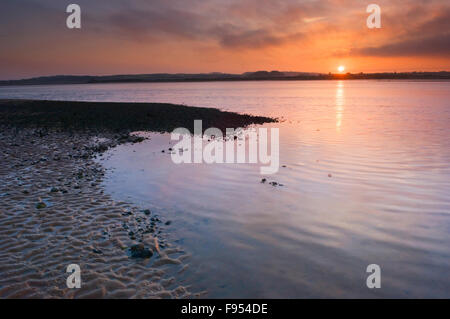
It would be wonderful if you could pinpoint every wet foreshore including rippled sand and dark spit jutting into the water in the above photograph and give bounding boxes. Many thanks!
[0,101,274,298]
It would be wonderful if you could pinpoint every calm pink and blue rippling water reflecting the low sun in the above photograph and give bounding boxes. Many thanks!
[0,81,450,298]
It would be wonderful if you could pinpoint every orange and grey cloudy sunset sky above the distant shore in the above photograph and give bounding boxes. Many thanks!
[0,0,450,79]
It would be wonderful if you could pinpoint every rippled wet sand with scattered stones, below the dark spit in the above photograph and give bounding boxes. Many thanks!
[0,128,192,298]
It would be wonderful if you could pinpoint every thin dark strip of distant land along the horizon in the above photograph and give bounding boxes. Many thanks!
[0,71,450,86]
